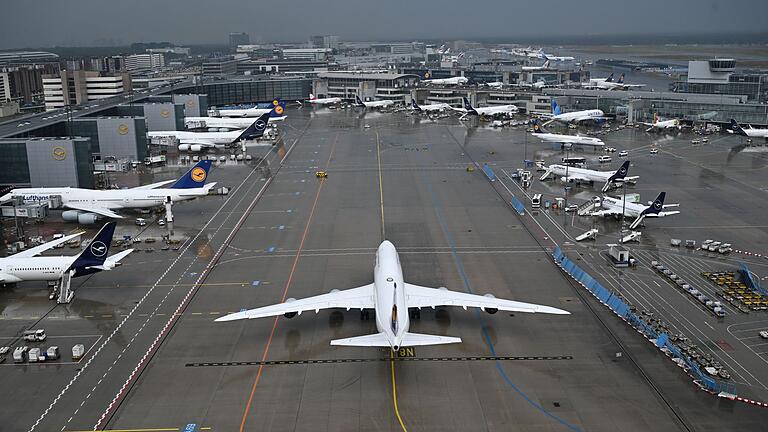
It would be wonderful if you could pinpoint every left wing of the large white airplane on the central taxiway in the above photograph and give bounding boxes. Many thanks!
[216,284,374,321]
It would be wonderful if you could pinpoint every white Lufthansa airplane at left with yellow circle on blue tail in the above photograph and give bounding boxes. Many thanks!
[0,159,216,224]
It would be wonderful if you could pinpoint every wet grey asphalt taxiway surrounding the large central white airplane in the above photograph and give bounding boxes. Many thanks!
[0,109,764,431]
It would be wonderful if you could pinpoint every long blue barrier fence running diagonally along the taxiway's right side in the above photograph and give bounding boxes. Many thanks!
[552,247,736,395]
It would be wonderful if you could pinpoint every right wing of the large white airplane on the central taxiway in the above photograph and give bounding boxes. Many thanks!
[405,283,570,315]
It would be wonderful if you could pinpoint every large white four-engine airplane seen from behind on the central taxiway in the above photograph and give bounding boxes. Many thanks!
[216,240,570,351]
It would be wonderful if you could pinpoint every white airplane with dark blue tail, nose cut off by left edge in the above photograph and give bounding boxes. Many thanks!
[0,222,133,284]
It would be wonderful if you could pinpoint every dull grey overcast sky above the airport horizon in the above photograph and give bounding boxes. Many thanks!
[0,0,768,49]
